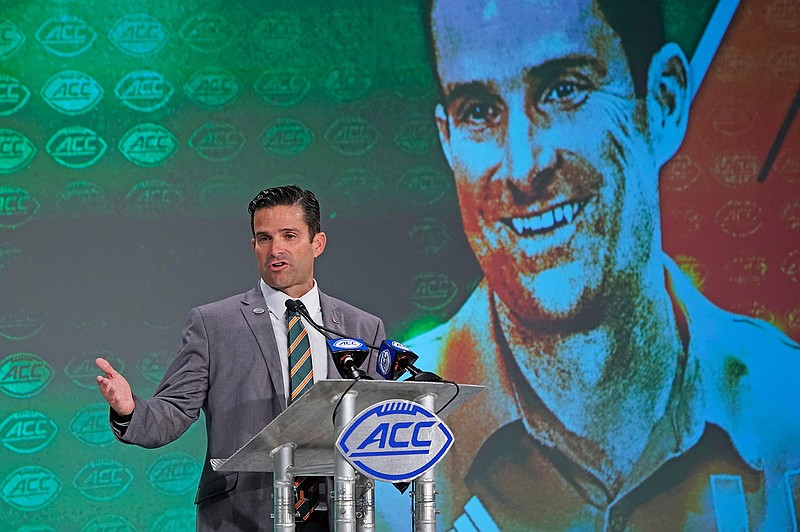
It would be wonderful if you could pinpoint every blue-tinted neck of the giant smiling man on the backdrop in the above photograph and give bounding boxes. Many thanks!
[495,268,684,492]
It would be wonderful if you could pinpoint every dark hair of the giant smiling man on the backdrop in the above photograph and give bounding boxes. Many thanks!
[423,0,666,97]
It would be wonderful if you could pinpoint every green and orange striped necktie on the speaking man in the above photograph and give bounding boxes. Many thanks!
[288,304,320,521]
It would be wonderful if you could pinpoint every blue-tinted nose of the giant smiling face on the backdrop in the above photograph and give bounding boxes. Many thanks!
[502,104,556,195]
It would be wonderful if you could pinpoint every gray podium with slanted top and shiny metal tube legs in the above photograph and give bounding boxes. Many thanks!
[211,379,483,532]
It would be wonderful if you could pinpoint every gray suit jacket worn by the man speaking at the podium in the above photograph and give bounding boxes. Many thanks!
[118,284,385,530]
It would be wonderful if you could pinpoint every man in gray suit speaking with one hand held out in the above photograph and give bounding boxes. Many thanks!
[96,186,385,530]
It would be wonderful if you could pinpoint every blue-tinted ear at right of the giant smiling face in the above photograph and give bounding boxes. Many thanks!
[647,43,692,166]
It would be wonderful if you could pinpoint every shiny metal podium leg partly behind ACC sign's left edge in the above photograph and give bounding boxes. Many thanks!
[333,391,357,532]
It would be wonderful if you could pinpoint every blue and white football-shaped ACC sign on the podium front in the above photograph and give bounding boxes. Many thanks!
[336,400,453,482]
